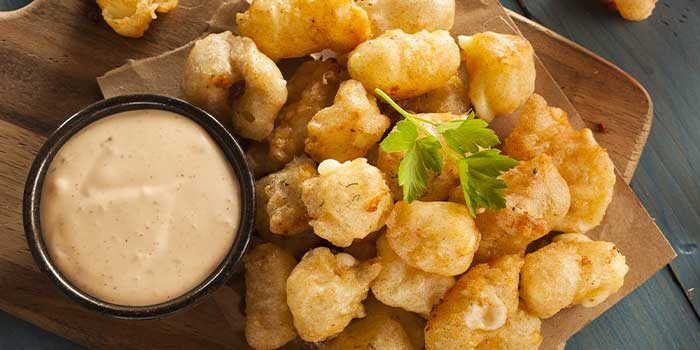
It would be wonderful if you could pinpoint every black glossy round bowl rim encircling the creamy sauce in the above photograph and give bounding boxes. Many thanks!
[23,95,255,319]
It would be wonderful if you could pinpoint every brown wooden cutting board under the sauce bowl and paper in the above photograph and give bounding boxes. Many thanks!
[0,0,652,349]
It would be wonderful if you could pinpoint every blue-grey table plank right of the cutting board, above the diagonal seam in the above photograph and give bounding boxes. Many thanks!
[504,0,700,313]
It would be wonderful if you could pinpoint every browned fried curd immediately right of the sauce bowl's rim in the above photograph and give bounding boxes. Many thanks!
[255,157,318,236]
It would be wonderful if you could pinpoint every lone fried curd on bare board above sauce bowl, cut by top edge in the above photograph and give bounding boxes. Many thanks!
[97,0,178,38]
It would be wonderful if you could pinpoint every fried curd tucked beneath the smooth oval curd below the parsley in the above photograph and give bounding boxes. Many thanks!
[372,235,455,317]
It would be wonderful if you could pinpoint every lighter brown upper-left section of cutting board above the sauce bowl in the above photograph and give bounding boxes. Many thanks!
[0,0,226,134]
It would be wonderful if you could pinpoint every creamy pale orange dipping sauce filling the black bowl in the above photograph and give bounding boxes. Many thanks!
[41,109,241,306]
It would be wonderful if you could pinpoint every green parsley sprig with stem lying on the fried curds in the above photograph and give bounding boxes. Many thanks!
[374,89,518,216]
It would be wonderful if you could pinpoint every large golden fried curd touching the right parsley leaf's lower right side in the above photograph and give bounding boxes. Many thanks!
[450,154,571,263]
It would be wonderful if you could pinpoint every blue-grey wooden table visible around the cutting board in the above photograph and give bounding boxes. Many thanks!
[0,0,700,349]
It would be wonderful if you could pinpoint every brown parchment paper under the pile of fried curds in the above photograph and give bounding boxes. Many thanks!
[97,0,675,349]
